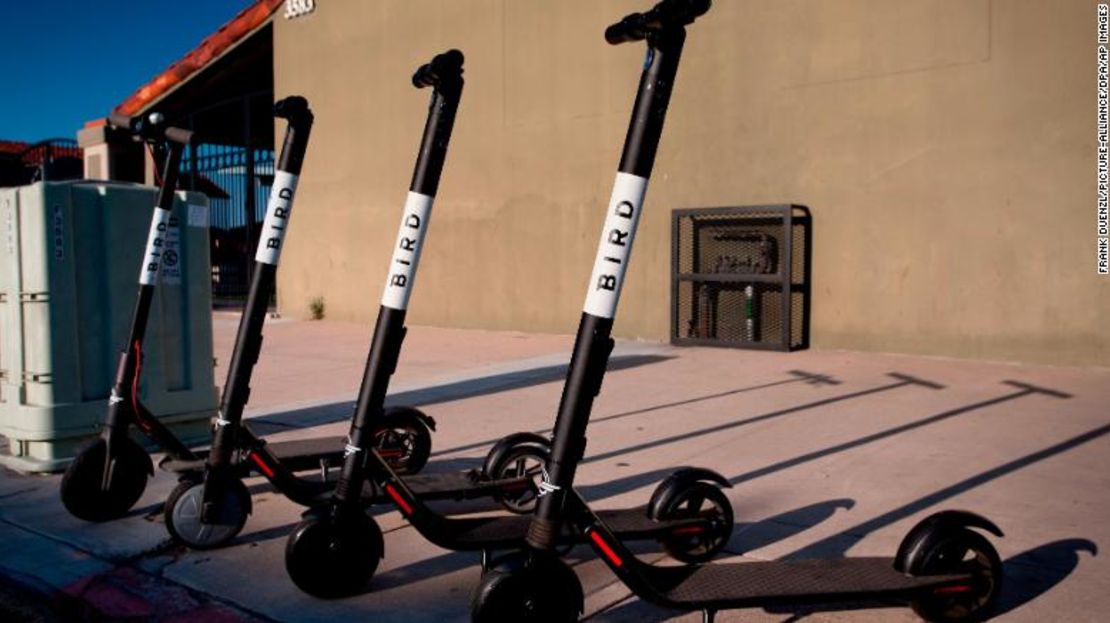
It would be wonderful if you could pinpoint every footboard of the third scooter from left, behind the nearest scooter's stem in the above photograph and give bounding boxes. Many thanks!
[452,505,690,550]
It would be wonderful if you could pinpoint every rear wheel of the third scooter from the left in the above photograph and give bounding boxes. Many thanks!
[660,482,733,563]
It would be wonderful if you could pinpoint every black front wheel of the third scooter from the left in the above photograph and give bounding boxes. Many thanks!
[285,511,385,600]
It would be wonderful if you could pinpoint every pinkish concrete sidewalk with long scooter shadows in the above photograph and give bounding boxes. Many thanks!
[0,314,1110,622]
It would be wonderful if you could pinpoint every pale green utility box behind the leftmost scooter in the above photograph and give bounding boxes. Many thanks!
[0,181,216,472]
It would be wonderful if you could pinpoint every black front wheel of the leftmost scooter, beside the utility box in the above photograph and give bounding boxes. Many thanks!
[61,436,153,522]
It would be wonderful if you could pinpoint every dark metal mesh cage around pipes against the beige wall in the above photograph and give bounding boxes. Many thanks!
[670,205,813,351]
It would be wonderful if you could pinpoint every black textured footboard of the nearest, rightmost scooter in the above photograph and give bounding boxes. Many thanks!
[645,557,967,609]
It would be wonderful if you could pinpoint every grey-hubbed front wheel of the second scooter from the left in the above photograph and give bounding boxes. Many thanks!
[164,478,251,550]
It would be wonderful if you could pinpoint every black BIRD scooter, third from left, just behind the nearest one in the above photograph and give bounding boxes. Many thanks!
[285,47,733,599]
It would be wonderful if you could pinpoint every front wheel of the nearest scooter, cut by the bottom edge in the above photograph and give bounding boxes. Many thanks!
[471,552,584,623]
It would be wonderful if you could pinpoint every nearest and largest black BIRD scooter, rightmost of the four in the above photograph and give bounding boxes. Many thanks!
[471,0,1002,623]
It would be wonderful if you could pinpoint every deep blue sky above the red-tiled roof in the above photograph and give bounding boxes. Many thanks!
[0,0,251,141]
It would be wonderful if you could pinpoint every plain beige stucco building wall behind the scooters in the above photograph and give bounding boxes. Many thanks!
[274,0,1110,365]
